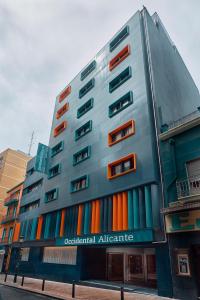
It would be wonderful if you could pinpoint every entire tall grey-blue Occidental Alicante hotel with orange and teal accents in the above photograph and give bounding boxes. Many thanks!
[10,8,200,296]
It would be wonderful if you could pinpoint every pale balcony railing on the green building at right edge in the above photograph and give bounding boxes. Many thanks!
[176,174,200,199]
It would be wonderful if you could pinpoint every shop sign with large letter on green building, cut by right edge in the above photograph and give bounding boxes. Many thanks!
[165,209,200,233]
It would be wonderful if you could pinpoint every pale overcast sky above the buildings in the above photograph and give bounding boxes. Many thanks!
[0,0,200,155]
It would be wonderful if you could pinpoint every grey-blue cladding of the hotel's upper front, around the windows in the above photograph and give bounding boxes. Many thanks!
[41,13,158,213]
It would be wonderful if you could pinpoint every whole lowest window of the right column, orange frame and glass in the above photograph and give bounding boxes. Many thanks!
[108,153,136,179]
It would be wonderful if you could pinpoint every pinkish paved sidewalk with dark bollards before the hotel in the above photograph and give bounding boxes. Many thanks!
[0,274,174,300]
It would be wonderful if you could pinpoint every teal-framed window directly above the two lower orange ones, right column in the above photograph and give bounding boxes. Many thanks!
[109,92,133,118]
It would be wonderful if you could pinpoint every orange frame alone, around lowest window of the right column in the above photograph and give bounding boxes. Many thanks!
[107,153,136,179]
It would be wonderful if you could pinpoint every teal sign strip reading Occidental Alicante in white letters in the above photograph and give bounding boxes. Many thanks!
[56,230,153,246]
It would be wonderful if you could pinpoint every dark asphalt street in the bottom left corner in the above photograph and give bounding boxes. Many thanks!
[0,284,49,300]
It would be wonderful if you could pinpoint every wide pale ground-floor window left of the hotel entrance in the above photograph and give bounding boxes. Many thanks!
[43,246,77,265]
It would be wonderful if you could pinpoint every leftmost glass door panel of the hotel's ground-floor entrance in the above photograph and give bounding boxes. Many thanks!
[107,253,124,281]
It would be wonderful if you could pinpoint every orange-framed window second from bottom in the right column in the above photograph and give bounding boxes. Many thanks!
[108,120,135,146]
